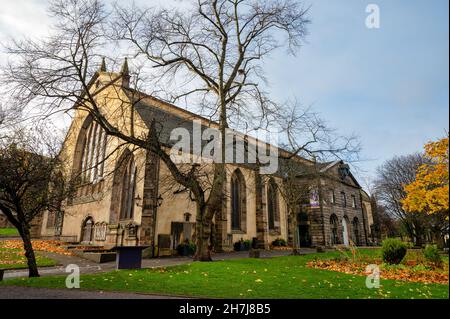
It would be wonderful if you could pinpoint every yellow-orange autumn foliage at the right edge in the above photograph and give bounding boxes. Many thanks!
[402,137,449,214]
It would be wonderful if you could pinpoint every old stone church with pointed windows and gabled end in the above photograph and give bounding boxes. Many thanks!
[40,60,373,256]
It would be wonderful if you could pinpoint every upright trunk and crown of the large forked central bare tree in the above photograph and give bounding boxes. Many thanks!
[112,0,309,260]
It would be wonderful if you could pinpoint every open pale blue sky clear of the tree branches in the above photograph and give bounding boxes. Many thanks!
[0,0,449,186]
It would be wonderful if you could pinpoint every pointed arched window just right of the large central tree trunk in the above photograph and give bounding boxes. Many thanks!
[231,170,247,231]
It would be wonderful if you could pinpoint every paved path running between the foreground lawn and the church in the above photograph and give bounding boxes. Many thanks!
[3,249,308,280]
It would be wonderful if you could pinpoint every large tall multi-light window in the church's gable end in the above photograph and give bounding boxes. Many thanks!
[81,121,107,183]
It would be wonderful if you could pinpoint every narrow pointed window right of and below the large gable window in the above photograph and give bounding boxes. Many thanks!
[120,156,137,220]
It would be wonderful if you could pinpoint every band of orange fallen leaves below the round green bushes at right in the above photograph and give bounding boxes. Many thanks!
[307,260,449,285]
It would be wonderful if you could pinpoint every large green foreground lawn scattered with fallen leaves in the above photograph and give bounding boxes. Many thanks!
[2,250,449,299]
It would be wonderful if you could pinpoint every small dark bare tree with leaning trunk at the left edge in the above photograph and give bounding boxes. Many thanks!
[0,128,73,277]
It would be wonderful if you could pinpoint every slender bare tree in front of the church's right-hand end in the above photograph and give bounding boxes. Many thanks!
[276,103,361,255]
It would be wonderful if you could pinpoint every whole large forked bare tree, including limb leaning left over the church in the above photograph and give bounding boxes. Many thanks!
[2,0,362,261]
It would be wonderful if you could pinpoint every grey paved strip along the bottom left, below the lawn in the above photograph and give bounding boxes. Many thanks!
[0,286,186,299]
